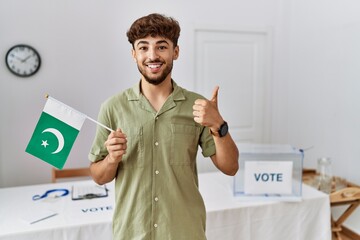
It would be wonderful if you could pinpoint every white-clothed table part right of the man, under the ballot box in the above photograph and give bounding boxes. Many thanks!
[199,173,331,240]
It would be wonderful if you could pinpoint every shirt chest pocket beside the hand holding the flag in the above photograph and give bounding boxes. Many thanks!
[122,127,144,168]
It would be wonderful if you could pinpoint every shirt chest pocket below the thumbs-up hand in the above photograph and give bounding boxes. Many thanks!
[170,124,200,165]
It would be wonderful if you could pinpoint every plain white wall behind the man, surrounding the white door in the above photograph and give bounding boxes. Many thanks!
[0,0,360,233]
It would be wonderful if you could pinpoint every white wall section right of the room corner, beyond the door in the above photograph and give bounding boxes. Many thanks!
[280,0,360,233]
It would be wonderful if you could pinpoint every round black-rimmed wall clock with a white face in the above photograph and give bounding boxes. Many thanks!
[5,44,41,77]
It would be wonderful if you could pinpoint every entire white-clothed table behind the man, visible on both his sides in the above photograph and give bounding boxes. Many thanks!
[0,173,331,240]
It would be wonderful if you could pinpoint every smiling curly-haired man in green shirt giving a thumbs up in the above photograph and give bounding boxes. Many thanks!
[89,14,239,240]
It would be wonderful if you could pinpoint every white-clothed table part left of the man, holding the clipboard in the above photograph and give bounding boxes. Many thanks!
[0,180,114,240]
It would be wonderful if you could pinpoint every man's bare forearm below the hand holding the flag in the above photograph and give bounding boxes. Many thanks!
[90,155,119,185]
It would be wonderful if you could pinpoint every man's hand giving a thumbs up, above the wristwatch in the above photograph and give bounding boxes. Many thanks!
[193,86,224,132]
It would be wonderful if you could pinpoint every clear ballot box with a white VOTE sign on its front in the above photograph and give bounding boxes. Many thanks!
[234,144,304,201]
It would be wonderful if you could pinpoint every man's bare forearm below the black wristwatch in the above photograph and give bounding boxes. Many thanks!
[211,133,239,176]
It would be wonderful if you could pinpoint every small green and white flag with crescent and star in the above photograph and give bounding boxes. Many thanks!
[26,97,86,169]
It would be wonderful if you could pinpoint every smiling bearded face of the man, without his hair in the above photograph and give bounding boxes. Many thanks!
[132,36,179,85]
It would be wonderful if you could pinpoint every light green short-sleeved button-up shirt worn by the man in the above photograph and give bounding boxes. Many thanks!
[89,82,215,240]
